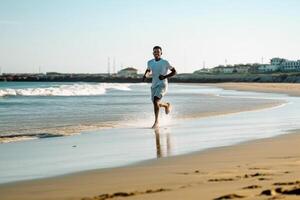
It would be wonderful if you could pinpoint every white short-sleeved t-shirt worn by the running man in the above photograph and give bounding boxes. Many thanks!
[147,58,173,88]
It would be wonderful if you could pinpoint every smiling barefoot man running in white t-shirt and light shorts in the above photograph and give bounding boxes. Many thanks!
[143,46,176,128]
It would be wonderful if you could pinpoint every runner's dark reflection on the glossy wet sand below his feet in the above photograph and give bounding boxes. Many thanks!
[154,128,171,158]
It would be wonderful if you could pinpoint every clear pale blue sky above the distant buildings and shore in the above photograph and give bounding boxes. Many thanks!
[0,0,300,73]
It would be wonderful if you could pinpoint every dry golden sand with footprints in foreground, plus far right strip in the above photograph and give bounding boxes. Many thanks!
[0,83,300,200]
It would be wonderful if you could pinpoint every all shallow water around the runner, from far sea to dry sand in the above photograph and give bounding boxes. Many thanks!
[0,83,300,183]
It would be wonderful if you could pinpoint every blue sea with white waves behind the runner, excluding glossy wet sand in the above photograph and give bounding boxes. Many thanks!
[0,82,278,141]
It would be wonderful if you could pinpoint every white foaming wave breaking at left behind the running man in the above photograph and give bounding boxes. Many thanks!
[0,83,131,97]
